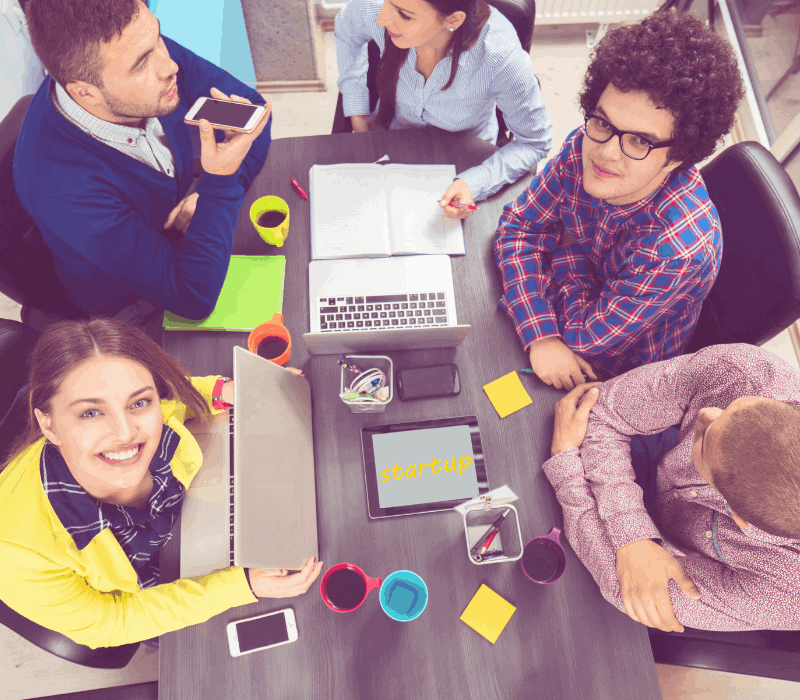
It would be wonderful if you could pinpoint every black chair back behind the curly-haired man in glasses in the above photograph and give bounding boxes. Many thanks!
[687,141,800,352]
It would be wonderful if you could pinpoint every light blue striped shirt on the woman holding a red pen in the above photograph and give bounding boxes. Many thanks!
[335,0,553,201]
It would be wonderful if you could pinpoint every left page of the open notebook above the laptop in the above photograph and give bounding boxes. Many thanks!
[309,163,392,260]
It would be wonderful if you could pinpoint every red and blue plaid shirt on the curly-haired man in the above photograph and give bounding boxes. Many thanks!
[494,127,722,375]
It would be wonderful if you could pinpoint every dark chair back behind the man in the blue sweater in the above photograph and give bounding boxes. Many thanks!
[0,95,86,326]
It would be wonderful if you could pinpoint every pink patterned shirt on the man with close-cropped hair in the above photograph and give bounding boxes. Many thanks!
[543,345,800,631]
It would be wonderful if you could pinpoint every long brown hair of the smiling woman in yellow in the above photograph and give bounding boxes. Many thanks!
[0,318,210,471]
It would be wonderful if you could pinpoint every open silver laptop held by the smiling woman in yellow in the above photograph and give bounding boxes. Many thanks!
[181,346,319,577]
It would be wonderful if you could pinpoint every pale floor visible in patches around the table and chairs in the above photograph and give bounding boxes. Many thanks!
[0,25,800,700]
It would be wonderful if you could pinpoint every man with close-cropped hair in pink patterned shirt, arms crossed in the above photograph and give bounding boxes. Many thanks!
[543,344,800,632]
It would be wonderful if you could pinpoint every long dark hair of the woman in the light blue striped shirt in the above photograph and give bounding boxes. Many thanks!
[376,0,491,129]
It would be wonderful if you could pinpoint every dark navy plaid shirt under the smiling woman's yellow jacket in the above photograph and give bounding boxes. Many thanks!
[39,425,186,589]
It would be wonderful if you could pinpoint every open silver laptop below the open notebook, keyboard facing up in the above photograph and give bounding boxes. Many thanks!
[303,255,470,355]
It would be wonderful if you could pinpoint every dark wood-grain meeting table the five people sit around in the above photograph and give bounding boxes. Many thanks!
[159,131,661,700]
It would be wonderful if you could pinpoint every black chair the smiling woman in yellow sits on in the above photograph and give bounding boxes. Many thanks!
[0,318,139,668]
